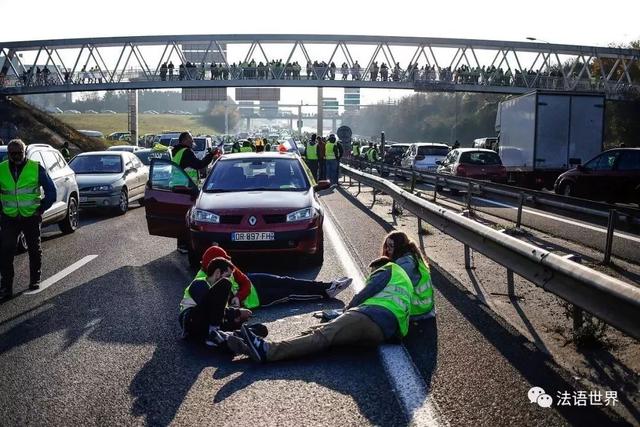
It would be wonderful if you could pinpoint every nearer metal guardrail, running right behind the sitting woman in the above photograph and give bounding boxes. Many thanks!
[341,164,640,339]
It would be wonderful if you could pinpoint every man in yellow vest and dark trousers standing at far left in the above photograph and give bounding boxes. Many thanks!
[0,139,57,300]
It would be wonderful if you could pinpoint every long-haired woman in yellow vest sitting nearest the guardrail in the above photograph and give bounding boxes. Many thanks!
[382,231,436,321]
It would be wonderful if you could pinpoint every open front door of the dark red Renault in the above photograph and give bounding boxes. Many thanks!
[144,159,200,238]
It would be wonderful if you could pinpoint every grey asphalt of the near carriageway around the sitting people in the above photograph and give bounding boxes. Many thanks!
[0,195,632,426]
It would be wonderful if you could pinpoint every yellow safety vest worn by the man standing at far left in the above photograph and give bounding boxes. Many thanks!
[0,160,40,218]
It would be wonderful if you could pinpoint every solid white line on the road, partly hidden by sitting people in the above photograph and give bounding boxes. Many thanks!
[324,215,447,426]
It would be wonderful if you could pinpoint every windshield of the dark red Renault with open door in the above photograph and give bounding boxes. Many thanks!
[204,158,309,193]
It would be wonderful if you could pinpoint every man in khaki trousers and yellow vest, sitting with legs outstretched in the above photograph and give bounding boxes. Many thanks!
[227,257,413,363]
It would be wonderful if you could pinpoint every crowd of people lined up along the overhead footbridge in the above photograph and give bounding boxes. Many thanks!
[0,59,632,92]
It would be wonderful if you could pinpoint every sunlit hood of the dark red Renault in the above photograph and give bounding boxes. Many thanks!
[196,190,313,211]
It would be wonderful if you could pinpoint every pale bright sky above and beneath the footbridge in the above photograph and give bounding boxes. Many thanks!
[0,0,640,106]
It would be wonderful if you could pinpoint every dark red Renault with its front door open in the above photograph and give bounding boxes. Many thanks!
[144,153,329,266]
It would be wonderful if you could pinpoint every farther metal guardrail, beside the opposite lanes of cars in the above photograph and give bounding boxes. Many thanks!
[343,159,640,224]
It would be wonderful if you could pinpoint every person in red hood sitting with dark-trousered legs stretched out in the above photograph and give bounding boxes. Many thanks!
[194,246,352,310]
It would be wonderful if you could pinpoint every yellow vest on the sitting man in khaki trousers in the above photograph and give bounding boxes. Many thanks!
[361,262,413,337]
